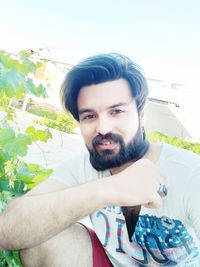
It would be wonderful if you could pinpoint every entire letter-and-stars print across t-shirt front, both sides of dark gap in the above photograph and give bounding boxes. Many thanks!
[92,206,200,267]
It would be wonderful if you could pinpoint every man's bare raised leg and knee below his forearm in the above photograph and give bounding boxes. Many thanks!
[20,224,93,267]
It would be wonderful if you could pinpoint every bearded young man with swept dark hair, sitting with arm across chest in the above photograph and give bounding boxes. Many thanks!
[0,54,200,267]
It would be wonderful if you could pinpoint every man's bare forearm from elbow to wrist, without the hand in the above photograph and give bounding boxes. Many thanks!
[0,179,109,249]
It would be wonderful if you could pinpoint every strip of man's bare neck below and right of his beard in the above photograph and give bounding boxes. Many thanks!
[110,143,162,175]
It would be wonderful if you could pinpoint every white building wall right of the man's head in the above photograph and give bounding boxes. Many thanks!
[145,100,200,142]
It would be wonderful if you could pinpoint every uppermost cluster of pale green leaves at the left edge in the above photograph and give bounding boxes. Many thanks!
[0,50,47,102]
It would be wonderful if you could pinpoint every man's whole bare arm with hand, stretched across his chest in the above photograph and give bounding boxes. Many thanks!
[0,160,163,252]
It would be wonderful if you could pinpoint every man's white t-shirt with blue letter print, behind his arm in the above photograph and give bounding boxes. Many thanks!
[51,144,200,267]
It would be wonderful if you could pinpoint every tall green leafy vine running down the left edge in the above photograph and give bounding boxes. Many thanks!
[0,50,52,267]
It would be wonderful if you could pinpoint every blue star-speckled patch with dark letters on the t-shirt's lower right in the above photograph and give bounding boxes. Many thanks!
[132,215,199,266]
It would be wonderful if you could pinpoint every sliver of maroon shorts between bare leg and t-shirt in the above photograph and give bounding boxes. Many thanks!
[81,225,113,267]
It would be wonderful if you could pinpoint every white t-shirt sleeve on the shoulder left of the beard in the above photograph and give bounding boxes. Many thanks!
[49,153,98,187]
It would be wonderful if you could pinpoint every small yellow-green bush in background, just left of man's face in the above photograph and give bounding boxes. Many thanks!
[37,112,77,133]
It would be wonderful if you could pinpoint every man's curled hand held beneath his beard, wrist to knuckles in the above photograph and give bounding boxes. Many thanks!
[110,159,165,208]
